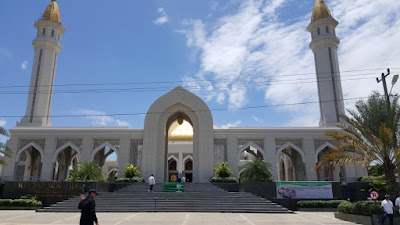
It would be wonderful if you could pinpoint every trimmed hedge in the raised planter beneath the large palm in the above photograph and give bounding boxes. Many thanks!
[338,201,383,216]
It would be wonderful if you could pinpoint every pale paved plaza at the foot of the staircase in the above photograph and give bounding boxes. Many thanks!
[0,210,354,225]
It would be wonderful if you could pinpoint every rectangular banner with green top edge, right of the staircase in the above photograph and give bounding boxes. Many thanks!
[276,181,333,199]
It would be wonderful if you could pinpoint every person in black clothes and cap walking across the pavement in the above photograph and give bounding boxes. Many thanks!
[78,189,99,225]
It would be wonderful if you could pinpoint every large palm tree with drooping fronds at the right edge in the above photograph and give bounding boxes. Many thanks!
[317,92,400,197]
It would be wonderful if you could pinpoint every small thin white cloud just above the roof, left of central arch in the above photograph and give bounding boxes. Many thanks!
[76,109,131,127]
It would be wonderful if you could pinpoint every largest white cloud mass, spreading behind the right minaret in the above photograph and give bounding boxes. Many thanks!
[185,0,400,126]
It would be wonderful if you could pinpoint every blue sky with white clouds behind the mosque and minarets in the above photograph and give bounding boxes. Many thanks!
[0,0,400,145]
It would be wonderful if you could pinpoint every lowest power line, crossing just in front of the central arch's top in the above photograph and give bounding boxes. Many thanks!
[0,97,368,118]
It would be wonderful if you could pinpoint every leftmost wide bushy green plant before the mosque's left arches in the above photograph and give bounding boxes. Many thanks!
[69,161,104,182]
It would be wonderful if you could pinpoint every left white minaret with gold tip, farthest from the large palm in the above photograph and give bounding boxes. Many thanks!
[17,0,65,127]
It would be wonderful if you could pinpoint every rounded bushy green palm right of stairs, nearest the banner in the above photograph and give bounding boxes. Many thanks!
[240,158,272,182]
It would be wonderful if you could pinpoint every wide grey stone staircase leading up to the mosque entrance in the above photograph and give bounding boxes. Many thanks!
[37,183,290,213]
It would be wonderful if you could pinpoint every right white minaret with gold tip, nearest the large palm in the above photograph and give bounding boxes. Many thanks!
[307,0,345,127]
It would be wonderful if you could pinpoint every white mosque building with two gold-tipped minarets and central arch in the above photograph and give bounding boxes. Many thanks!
[2,0,366,183]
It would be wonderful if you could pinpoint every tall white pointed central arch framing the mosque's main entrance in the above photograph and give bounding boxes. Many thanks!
[142,87,214,183]
